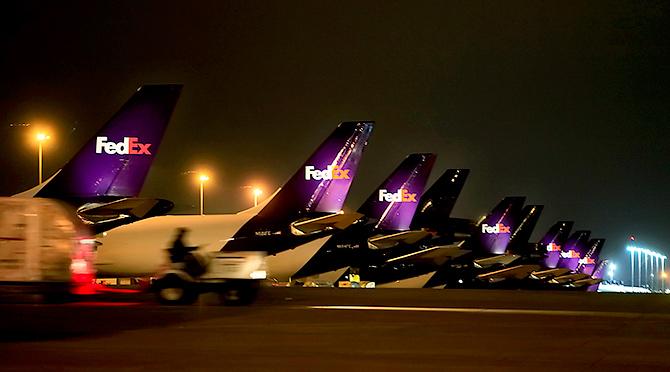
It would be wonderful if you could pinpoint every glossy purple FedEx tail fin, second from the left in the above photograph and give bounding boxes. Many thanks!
[258,121,374,220]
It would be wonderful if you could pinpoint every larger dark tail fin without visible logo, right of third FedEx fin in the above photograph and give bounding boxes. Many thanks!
[411,169,470,230]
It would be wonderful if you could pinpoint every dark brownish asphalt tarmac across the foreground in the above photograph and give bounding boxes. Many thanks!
[0,288,670,371]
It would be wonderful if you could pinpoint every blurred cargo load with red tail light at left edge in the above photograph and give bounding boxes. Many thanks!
[0,197,95,302]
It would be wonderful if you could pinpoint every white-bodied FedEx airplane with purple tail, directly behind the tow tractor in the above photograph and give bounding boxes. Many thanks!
[96,121,373,281]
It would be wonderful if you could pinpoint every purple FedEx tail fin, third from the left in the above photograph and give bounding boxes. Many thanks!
[358,154,436,231]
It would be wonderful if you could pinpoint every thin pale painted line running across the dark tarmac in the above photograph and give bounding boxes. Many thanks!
[307,306,670,319]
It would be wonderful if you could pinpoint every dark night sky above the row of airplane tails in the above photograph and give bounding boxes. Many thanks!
[0,1,670,274]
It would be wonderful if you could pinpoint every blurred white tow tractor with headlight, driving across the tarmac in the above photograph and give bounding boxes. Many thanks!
[152,251,267,305]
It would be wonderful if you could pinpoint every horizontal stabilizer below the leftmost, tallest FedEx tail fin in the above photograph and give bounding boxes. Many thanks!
[77,198,174,224]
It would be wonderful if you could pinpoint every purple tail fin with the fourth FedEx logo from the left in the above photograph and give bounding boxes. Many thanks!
[478,196,526,255]
